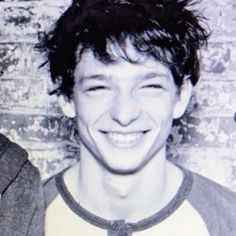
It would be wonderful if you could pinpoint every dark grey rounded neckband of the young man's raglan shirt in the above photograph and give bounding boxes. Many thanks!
[55,167,193,235]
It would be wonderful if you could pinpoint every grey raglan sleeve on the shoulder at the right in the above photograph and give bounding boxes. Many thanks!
[188,170,236,235]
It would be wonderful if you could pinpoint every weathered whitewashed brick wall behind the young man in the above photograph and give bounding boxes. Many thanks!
[0,0,236,188]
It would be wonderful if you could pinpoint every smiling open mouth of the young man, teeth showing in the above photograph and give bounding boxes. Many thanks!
[102,131,148,148]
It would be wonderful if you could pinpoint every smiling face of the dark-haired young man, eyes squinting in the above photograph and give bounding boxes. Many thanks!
[67,45,190,174]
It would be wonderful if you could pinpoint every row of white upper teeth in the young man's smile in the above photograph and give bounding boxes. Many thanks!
[108,132,143,144]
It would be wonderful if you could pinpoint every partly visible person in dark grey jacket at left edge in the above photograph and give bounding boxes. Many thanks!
[0,134,44,236]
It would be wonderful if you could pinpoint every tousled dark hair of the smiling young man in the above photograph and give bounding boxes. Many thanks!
[41,0,208,99]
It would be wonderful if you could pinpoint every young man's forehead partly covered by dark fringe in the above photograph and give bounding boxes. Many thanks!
[75,47,171,78]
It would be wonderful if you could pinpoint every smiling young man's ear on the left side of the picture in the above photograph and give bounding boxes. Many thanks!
[57,95,76,118]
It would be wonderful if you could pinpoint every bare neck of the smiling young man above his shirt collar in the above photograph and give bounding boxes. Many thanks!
[65,148,182,222]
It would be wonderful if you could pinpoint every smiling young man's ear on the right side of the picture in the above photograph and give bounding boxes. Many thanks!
[173,78,193,119]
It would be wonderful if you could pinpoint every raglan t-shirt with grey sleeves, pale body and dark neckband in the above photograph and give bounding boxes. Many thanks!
[45,169,236,236]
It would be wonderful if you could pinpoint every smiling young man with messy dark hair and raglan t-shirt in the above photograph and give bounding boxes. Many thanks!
[41,0,236,236]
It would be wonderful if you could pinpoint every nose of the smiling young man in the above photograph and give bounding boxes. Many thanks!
[110,95,141,126]
